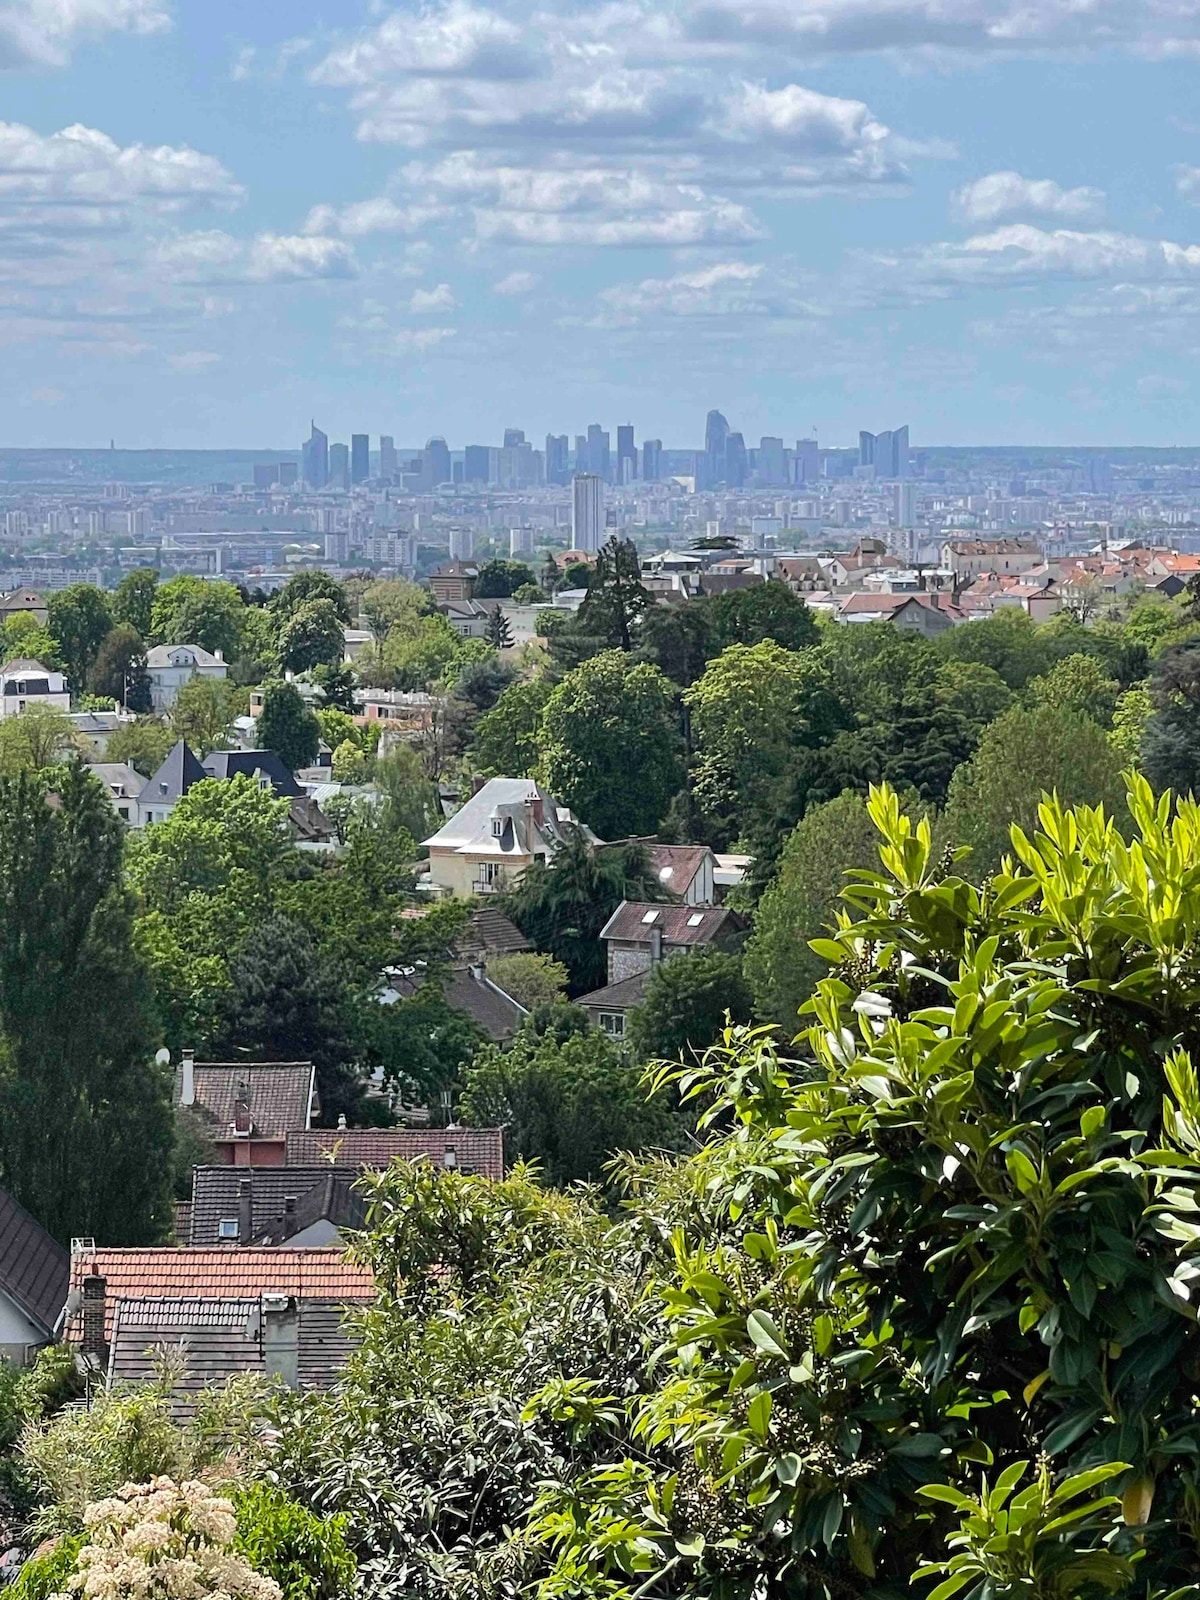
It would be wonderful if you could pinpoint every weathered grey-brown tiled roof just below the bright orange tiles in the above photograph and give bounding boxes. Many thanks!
[109,1292,358,1413]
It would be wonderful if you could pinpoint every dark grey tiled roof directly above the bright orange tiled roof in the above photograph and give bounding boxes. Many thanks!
[189,1163,365,1246]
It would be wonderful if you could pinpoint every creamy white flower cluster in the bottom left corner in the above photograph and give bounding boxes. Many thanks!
[51,1477,282,1600]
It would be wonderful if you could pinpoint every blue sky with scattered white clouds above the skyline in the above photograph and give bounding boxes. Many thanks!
[0,0,1200,448]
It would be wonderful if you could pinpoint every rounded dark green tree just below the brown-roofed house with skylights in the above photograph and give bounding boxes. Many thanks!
[627,950,754,1062]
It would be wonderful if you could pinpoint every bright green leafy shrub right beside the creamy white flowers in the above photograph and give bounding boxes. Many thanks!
[234,1482,355,1600]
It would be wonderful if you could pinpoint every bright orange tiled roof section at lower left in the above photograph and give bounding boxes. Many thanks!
[67,1245,374,1338]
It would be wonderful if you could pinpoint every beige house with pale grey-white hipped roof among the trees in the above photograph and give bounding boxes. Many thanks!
[426,778,598,894]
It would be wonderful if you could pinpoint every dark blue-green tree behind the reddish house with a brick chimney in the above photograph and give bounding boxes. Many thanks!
[216,915,362,1126]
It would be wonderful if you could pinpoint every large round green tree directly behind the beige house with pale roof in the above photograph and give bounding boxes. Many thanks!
[538,650,683,837]
